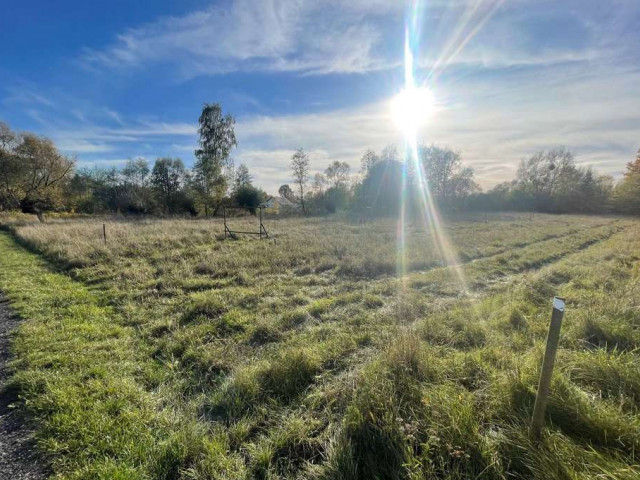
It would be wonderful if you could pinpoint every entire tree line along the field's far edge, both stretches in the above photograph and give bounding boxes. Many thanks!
[0,104,640,220]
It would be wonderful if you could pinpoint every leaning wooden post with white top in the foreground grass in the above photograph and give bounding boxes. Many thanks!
[531,297,564,438]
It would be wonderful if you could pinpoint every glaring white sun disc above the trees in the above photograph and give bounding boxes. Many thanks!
[391,87,435,136]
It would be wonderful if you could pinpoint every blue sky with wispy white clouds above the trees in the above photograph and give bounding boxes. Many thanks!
[0,0,640,193]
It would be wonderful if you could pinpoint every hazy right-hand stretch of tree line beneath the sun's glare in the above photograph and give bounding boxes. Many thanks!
[279,145,640,215]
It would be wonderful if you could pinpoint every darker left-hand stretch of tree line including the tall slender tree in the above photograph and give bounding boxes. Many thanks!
[0,104,267,220]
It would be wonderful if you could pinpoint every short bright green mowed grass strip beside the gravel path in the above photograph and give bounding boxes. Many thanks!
[0,232,242,480]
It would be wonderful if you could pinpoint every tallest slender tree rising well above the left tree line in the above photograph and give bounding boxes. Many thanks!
[194,103,237,215]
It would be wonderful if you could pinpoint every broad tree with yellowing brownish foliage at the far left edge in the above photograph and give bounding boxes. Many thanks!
[0,123,75,221]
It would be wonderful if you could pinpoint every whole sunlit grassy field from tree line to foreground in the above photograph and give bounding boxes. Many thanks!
[0,214,640,480]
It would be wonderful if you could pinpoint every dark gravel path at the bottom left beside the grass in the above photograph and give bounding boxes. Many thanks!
[0,293,47,480]
